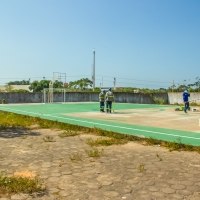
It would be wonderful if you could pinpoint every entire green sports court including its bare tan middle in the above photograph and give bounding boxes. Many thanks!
[0,102,200,146]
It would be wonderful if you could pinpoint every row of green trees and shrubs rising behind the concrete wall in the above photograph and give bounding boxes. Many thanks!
[0,77,200,93]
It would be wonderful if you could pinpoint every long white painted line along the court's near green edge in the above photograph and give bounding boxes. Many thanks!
[1,108,200,140]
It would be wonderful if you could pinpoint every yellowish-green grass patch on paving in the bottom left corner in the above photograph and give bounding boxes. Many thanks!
[0,174,46,197]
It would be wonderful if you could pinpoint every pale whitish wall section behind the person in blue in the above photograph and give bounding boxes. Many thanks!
[168,92,200,104]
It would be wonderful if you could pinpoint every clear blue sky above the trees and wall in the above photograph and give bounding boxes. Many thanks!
[0,0,200,89]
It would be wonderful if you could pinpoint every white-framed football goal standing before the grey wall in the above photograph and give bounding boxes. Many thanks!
[43,88,66,104]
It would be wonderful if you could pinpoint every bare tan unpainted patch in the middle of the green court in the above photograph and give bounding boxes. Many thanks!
[67,107,200,133]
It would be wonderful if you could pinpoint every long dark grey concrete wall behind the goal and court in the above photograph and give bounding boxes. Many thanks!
[0,92,168,104]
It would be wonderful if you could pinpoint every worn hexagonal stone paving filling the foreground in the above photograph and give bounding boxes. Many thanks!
[0,129,200,200]
